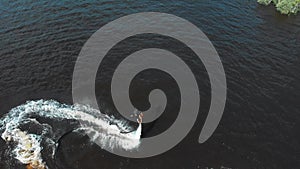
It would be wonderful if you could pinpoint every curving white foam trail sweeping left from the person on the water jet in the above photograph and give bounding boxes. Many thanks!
[0,100,142,169]
